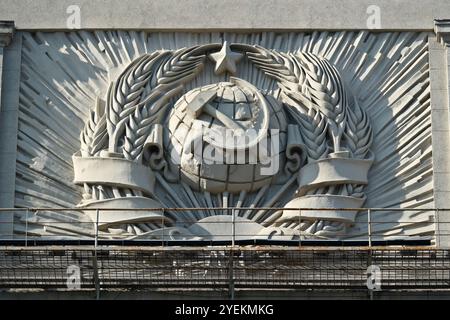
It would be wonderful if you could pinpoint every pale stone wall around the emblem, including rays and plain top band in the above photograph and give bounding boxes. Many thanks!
[0,0,450,247]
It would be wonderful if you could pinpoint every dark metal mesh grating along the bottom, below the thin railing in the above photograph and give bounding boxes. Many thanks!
[0,246,450,290]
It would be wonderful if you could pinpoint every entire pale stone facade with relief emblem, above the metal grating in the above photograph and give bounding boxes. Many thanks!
[0,0,450,247]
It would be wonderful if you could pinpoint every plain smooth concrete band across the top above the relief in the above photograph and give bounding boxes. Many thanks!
[0,0,450,32]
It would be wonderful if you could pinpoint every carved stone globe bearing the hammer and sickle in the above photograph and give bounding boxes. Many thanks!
[164,78,287,193]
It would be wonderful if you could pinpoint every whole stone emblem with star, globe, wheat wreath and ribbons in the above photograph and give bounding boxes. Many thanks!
[73,42,374,239]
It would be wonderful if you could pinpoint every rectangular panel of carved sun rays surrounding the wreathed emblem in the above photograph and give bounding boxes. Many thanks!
[10,31,434,238]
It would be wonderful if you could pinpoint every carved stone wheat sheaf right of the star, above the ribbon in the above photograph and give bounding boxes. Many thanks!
[247,46,372,202]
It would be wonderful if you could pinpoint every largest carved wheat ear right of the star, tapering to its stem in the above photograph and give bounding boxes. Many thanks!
[247,47,347,151]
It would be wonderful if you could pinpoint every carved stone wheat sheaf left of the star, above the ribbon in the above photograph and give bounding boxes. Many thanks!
[80,47,205,160]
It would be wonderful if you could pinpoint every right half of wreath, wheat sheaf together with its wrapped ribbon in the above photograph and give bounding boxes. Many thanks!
[248,47,373,230]
